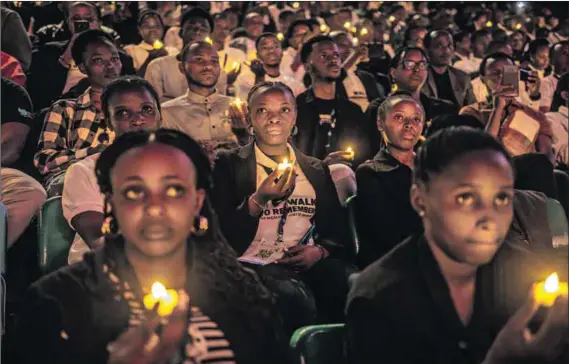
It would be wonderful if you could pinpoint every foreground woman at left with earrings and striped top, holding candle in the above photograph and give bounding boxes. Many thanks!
[17,129,288,364]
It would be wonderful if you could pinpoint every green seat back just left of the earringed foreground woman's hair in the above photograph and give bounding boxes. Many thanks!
[38,196,75,274]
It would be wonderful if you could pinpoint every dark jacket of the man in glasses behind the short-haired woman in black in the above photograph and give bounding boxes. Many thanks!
[365,92,458,153]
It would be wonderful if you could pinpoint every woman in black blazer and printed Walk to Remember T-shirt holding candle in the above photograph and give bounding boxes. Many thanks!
[212,82,353,333]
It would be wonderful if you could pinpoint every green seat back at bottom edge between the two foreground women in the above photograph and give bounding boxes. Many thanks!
[290,324,348,364]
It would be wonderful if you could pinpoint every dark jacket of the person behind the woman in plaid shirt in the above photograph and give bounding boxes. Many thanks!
[27,41,136,110]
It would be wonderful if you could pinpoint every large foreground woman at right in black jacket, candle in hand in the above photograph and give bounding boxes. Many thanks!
[347,127,569,364]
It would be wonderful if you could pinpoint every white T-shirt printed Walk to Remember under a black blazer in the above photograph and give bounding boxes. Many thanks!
[235,145,316,265]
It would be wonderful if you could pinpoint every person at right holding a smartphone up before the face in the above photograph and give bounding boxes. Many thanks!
[460,53,553,161]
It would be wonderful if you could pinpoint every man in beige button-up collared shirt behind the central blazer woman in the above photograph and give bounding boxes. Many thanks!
[162,41,249,163]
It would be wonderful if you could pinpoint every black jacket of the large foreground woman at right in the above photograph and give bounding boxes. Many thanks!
[346,236,567,364]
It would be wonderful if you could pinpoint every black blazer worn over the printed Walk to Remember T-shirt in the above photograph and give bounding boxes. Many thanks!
[211,143,351,259]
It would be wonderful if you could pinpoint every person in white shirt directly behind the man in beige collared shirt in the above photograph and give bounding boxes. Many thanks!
[144,8,227,102]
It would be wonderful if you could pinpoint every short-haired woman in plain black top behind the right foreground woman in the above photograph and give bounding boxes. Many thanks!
[356,95,425,268]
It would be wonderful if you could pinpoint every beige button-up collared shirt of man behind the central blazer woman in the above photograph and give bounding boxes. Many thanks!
[162,89,237,146]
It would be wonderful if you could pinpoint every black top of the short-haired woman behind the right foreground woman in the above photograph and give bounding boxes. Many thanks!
[356,148,423,268]
